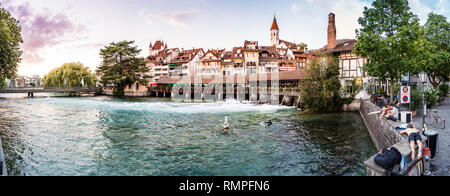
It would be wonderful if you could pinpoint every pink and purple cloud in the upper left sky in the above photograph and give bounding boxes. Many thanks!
[4,1,86,63]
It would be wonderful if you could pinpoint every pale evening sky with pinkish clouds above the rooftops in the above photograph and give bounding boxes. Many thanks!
[0,0,450,77]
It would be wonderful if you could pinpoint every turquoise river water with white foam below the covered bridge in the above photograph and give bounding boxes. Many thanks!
[0,94,376,176]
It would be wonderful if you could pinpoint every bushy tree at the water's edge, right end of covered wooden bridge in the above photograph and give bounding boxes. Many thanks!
[300,55,343,112]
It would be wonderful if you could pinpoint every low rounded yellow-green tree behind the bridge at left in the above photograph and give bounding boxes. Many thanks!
[44,62,96,87]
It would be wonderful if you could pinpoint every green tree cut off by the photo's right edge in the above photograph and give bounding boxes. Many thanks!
[418,13,450,88]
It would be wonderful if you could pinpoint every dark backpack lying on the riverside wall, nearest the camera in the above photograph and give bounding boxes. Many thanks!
[374,147,402,170]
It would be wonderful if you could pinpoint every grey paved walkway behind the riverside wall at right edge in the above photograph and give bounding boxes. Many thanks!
[413,98,450,176]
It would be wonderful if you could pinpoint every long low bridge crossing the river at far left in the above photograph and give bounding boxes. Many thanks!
[0,87,103,97]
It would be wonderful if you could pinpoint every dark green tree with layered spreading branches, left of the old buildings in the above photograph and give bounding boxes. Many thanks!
[97,41,149,96]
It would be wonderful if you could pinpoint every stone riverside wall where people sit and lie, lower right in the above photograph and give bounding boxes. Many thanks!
[359,100,426,176]
